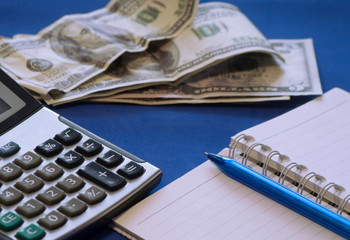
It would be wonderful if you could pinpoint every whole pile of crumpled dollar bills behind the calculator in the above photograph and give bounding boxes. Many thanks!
[0,0,322,105]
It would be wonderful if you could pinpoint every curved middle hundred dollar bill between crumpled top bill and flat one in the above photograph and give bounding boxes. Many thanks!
[43,2,279,104]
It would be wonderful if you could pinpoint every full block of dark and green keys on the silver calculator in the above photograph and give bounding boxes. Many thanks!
[0,124,157,239]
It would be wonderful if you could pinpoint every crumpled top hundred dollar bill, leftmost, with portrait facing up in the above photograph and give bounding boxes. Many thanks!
[0,0,199,94]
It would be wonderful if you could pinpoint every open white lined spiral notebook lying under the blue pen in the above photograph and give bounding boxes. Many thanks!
[113,88,350,240]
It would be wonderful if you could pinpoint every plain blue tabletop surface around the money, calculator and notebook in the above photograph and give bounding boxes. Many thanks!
[0,0,350,239]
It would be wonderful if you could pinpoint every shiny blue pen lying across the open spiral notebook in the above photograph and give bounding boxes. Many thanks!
[205,153,350,239]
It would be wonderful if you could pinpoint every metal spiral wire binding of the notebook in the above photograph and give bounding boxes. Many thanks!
[228,133,350,215]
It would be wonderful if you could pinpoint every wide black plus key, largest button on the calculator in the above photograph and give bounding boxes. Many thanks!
[78,162,126,191]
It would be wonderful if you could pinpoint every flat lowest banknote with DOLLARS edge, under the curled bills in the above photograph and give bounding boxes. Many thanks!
[105,39,322,102]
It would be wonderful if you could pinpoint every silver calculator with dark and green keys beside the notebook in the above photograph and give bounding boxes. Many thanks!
[0,68,162,240]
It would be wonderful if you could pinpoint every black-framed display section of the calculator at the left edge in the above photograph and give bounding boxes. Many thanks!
[0,69,42,136]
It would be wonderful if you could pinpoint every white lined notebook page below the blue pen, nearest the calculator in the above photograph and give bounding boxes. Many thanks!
[115,161,341,240]
